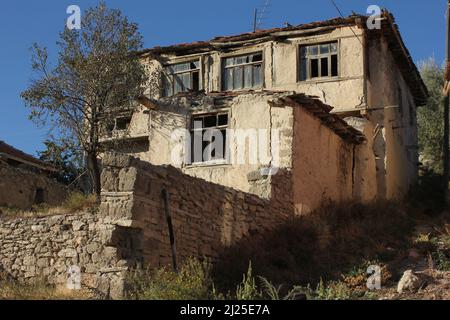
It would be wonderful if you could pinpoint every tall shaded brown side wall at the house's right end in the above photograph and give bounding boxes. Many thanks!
[367,37,418,199]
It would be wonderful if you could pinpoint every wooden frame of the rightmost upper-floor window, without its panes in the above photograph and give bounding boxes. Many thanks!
[297,39,341,82]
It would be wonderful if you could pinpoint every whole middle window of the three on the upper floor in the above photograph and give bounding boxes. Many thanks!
[222,52,263,91]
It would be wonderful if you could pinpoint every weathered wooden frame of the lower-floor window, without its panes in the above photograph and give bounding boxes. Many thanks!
[187,110,231,166]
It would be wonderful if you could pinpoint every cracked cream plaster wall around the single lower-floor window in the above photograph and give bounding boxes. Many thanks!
[141,93,293,197]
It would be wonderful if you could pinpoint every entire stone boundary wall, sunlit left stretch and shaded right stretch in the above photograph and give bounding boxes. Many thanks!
[0,154,293,298]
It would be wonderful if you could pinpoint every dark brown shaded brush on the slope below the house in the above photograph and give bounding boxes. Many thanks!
[214,202,413,290]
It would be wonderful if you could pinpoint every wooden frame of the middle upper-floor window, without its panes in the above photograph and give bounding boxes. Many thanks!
[220,50,265,91]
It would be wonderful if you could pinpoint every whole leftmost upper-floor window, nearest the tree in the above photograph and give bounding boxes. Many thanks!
[164,60,200,97]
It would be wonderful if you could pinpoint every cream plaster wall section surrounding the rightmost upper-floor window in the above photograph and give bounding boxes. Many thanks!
[265,27,365,112]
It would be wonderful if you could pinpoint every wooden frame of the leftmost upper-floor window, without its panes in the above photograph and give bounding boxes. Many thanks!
[162,57,202,97]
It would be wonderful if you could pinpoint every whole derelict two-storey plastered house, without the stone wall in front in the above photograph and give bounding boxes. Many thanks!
[105,11,427,213]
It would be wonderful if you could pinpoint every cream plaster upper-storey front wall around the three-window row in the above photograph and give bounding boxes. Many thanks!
[142,27,365,111]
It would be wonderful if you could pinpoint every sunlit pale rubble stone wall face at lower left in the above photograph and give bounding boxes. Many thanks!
[0,213,127,298]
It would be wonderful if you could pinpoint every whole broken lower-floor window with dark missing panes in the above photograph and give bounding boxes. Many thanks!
[191,113,228,163]
